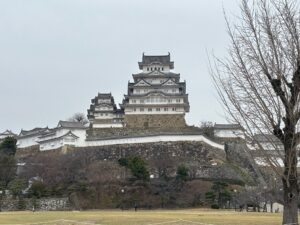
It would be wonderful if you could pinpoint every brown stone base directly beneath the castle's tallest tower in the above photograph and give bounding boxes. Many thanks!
[124,114,187,128]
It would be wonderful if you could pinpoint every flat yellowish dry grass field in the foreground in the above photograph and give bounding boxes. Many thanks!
[0,209,282,225]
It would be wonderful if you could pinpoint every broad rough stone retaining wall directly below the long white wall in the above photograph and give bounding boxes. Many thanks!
[58,141,245,182]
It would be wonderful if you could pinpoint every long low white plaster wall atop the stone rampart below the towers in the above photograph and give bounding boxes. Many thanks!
[82,135,224,151]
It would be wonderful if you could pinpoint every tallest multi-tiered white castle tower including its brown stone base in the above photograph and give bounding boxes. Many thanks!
[121,53,190,128]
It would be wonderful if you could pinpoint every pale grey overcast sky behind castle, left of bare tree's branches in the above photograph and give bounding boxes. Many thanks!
[0,0,238,133]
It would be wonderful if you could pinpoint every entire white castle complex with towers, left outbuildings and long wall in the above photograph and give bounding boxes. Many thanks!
[9,53,244,151]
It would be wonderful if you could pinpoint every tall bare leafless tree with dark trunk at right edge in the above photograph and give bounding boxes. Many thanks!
[210,0,300,224]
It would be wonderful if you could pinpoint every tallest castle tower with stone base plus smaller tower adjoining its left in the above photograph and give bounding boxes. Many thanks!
[88,53,190,128]
